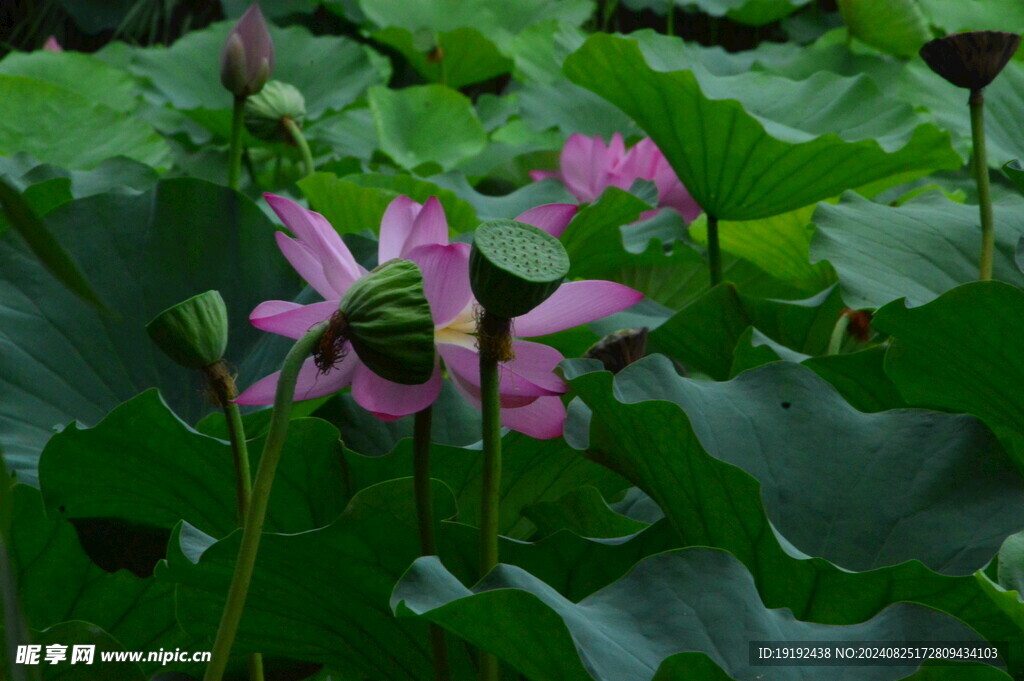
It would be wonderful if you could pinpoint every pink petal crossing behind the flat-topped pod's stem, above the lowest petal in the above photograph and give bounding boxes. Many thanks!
[437,340,566,407]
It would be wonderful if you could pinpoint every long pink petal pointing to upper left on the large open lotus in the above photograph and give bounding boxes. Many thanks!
[263,194,367,298]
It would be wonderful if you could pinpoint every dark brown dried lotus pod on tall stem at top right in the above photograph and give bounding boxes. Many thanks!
[921,31,1021,90]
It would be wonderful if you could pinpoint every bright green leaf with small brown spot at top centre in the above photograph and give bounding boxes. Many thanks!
[373,27,512,89]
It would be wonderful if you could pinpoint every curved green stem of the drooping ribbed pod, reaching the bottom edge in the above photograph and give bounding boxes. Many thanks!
[203,322,329,681]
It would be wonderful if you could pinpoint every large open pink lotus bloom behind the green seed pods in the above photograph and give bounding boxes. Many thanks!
[236,194,643,439]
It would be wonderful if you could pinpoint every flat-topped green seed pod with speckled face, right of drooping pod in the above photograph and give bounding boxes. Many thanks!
[469,220,569,320]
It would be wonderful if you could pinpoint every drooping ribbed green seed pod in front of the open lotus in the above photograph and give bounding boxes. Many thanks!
[338,260,434,385]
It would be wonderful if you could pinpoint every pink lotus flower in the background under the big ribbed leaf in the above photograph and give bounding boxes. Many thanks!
[529,132,701,222]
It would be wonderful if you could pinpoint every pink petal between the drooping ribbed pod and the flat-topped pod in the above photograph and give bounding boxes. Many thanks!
[406,244,473,329]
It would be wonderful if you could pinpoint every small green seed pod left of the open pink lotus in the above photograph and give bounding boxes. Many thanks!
[145,291,227,369]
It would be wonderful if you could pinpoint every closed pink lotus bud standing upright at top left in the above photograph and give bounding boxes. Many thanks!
[220,4,273,97]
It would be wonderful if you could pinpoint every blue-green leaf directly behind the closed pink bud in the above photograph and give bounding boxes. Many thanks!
[129,22,390,119]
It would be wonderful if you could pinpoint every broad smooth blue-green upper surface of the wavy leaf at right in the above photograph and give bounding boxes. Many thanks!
[573,356,1024,574]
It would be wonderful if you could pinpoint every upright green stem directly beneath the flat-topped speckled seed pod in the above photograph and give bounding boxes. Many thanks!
[477,312,511,681]
